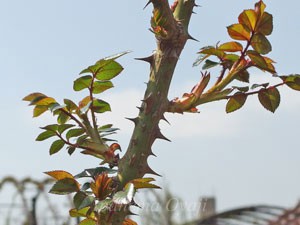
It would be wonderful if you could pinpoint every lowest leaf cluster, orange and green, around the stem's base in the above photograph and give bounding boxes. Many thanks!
[46,170,159,225]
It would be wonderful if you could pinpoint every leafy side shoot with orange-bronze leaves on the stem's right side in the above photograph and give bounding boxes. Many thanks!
[169,0,299,113]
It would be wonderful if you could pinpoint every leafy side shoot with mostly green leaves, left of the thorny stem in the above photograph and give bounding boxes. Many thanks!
[23,52,128,163]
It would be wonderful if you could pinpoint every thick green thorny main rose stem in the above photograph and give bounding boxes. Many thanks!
[113,0,195,222]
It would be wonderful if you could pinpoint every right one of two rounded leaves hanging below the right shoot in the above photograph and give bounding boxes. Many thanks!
[258,87,280,113]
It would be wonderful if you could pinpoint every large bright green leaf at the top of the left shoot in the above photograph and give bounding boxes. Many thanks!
[95,60,123,81]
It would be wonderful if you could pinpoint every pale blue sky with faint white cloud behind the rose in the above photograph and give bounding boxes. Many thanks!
[0,0,300,221]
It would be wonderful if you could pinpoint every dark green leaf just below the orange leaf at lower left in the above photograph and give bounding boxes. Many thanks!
[49,178,79,195]
